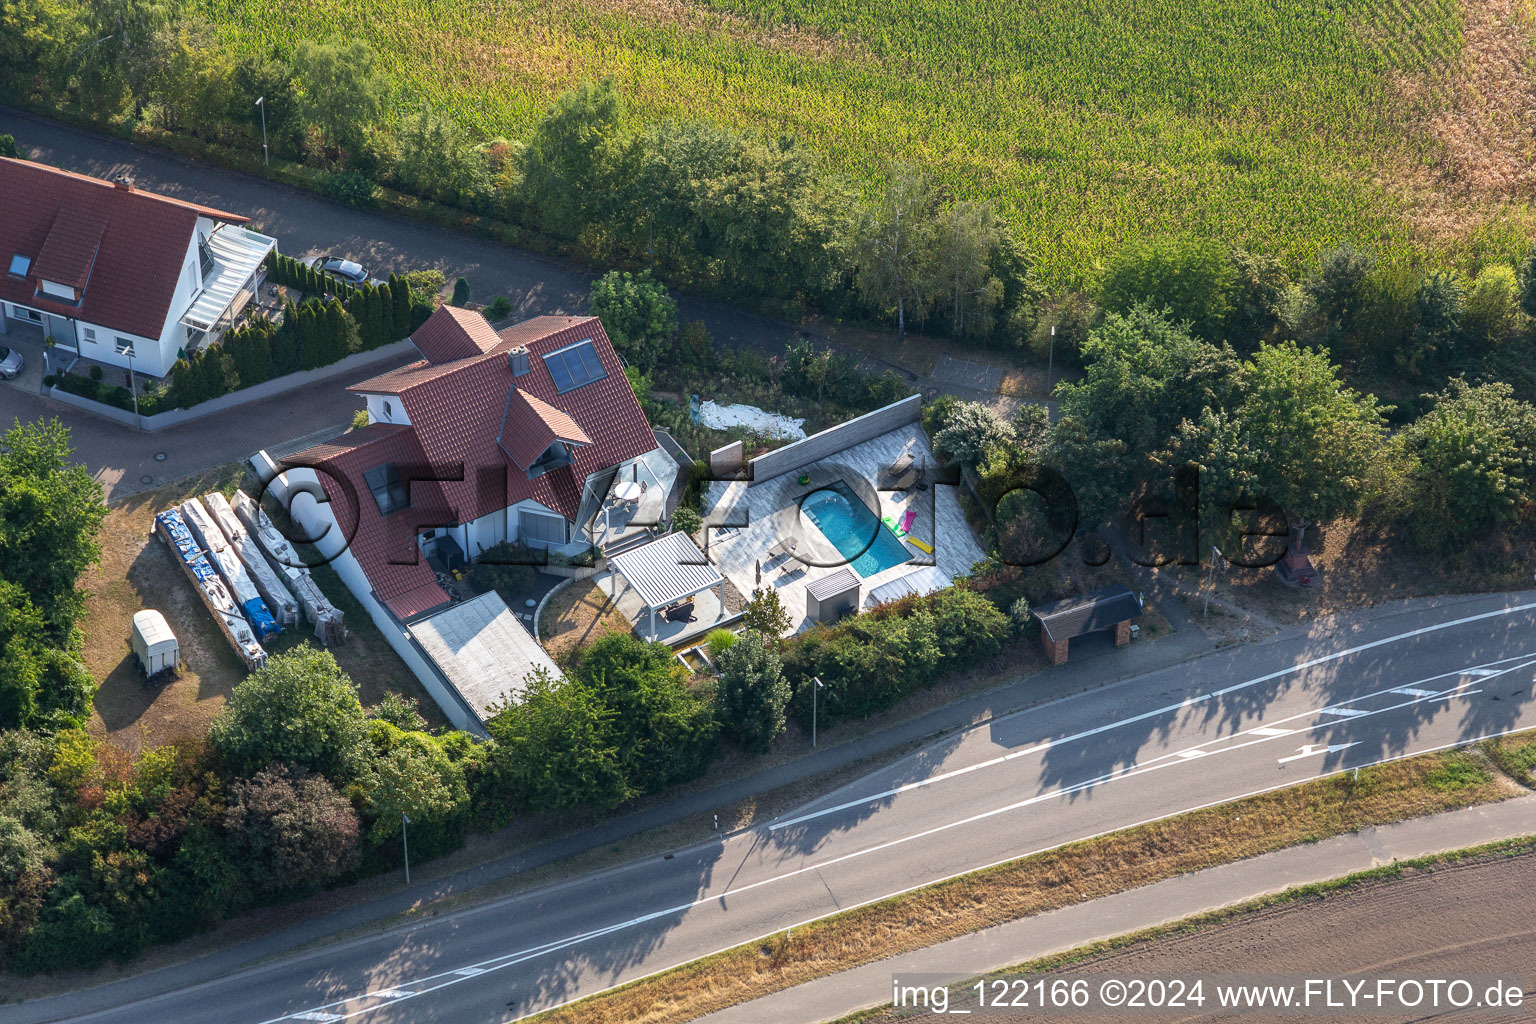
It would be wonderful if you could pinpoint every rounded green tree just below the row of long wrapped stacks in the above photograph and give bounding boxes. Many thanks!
[209,643,366,781]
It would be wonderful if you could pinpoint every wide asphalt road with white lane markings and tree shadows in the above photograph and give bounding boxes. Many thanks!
[29,594,1536,1024]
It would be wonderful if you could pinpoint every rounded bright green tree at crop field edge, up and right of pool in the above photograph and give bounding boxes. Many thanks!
[1098,238,1238,341]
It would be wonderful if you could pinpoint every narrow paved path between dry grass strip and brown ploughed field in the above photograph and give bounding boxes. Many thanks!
[699,795,1536,1024]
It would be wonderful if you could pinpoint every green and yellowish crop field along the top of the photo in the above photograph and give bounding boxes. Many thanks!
[197,0,1531,281]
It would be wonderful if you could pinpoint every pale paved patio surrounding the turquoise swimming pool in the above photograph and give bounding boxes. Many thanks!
[705,424,983,634]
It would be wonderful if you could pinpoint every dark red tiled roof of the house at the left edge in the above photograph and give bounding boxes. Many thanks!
[0,157,247,338]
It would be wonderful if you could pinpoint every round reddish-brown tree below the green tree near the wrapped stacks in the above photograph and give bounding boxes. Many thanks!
[223,765,361,895]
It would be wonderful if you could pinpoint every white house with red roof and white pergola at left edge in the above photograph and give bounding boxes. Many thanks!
[0,158,276,378]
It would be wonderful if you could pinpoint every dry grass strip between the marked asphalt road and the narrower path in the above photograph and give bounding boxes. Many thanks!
[531,752,1524,1024]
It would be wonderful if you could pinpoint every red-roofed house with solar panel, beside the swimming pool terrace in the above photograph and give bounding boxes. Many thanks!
[266,307,679,728]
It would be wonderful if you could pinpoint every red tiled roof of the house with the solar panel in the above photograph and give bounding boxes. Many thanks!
[284,316,656,616]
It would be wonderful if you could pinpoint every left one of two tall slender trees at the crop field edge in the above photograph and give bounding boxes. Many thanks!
[854,164,940,338]
